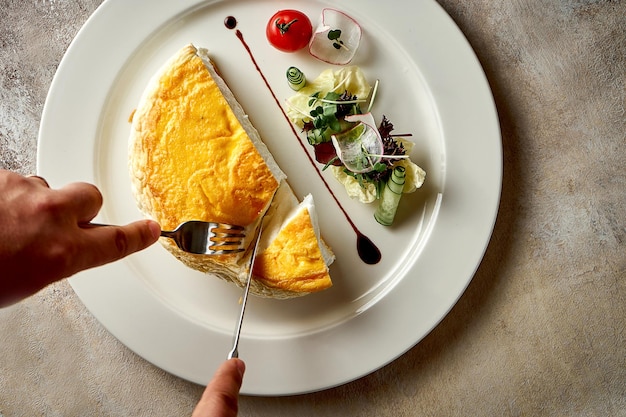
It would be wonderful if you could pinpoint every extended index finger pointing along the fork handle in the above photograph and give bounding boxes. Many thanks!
[71,220,161,270]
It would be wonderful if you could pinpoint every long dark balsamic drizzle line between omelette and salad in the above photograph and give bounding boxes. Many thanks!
[224,16,381,265]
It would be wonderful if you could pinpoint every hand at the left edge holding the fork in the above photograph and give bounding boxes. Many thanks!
[0,170,160,307]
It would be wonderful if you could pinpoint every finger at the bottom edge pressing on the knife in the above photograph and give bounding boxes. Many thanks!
[191,358,246,417]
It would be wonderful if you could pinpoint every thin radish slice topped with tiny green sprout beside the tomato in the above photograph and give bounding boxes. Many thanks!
[309,8,362,65]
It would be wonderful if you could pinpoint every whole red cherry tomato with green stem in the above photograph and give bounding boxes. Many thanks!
[265,9,313,52]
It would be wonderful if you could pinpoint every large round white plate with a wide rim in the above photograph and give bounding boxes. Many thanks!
[38,0,502,395]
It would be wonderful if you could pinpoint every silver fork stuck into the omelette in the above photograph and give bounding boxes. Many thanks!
[83,220,246,255]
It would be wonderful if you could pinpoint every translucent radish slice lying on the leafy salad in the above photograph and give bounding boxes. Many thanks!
[331,113,384,174]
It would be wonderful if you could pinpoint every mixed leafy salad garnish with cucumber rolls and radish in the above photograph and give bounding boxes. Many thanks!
[286,66,425,225]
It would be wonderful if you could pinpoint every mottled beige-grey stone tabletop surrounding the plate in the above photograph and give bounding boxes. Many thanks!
[0,0,626,417]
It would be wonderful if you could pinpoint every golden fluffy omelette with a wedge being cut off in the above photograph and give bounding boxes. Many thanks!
[129,45,334,298]
